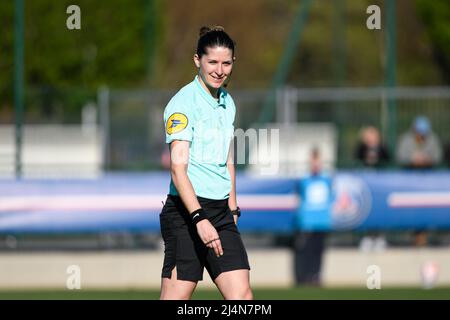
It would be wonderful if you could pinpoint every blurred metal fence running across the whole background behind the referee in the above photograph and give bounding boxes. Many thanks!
[4,87,450,175]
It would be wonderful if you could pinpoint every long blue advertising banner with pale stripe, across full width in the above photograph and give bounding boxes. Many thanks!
[0,171,450,234]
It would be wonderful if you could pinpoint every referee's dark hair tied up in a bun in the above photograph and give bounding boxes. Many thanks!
[197,26,235,57]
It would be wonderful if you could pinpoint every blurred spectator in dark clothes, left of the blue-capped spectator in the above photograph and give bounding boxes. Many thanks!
[355,126,390,168]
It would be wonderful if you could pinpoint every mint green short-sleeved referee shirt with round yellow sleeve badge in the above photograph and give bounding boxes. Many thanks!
[164,76,236,200]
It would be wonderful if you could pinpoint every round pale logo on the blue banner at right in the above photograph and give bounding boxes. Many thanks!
[331,175,372,229]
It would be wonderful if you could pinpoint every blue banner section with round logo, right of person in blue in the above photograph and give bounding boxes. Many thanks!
[332,171,450,229]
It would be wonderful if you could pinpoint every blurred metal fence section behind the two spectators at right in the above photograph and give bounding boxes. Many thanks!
[277,87,450,167]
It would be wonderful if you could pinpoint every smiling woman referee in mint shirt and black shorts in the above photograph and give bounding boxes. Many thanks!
[160,26,253,300]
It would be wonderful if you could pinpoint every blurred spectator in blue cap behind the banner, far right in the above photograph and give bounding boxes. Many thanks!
[397,116,442,169]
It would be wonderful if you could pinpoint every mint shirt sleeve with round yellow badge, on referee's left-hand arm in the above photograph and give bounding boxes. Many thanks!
[164,99,193,143]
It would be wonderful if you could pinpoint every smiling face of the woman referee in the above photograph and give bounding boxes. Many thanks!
[194,47,234,97]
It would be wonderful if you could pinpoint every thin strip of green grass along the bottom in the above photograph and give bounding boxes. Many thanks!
[0,287,450,300]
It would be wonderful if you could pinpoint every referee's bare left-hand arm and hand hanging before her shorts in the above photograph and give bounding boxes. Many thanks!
[170,140,223,256]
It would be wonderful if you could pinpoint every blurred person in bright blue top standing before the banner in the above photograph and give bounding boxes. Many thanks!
[293,148,333,286]
